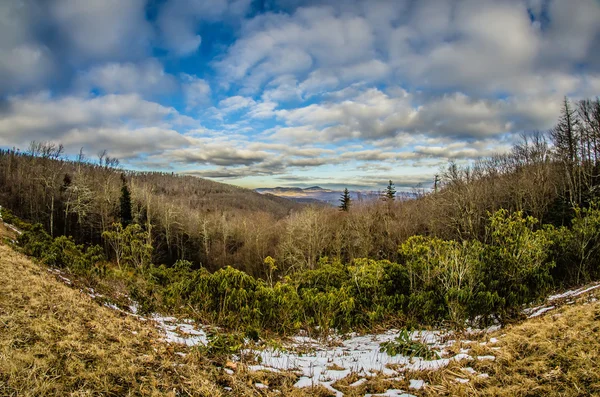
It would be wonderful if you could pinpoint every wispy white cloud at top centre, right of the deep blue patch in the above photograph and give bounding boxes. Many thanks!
[216,7,375,92]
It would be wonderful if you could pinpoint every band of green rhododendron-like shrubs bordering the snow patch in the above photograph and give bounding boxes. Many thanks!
[8,196,600,332]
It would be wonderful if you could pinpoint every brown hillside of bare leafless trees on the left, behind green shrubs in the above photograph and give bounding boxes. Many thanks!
[0,144,303,271]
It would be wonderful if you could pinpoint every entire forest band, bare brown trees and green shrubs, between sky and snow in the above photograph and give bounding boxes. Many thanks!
[0,98,600,336]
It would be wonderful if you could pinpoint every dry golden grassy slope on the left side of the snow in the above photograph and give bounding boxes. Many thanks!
[0,244,316,397]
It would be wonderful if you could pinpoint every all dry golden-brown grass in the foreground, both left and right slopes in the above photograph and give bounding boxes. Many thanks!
[0,234,600,397]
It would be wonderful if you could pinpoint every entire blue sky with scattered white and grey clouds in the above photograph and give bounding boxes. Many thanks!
[0,0,600,190]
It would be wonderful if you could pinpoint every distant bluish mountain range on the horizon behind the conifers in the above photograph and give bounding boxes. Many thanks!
[256,186,415,205]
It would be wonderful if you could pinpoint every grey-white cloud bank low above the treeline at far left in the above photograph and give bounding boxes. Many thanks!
[0,93,183,158]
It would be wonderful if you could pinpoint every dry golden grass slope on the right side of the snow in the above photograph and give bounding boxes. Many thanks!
[422,293,600,396]
